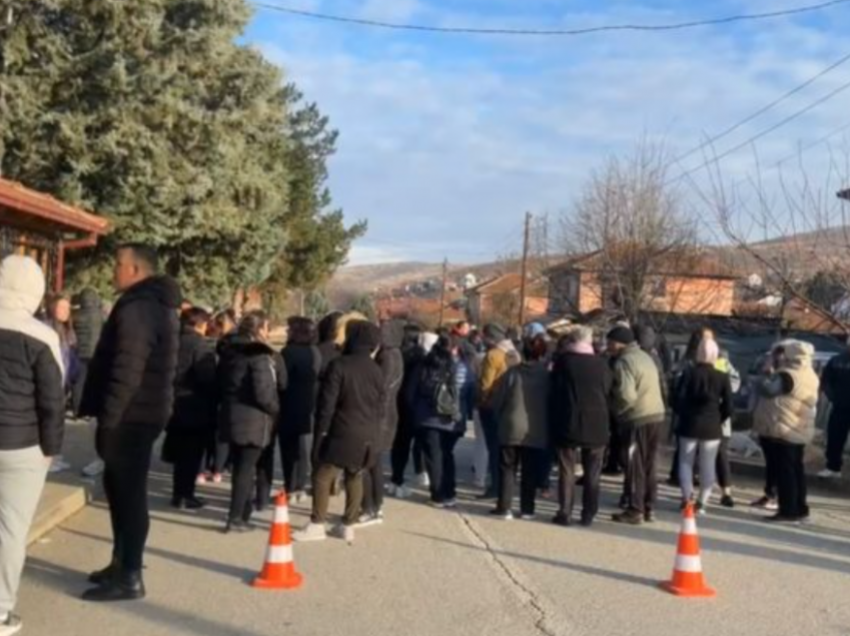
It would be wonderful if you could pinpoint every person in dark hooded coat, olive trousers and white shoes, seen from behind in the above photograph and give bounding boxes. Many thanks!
[293,320,386,543]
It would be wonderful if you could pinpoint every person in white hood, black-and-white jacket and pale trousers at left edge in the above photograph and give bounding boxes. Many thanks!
[0,256,65,634]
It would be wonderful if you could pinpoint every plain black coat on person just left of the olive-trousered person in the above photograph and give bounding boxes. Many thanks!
[279,344,322,438]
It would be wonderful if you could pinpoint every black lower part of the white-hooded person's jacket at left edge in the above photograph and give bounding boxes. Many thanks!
[0,326,65,457]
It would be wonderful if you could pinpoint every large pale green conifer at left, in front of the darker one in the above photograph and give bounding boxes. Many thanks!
[0,0,289,302]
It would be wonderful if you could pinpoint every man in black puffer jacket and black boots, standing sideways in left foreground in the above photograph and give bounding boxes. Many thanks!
[81,245,181,601]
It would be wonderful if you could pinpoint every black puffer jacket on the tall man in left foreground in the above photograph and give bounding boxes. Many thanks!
[80,276,181,434]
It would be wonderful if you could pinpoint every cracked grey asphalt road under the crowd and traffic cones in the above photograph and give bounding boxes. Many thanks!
[19,440,850,636]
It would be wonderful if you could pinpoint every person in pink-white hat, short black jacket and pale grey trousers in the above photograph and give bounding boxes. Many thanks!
[673,340,733,514]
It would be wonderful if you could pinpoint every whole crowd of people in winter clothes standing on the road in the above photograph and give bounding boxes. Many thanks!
[0,245,832,635]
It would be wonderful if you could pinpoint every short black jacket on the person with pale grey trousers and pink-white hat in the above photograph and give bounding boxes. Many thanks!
[674,364,733,440]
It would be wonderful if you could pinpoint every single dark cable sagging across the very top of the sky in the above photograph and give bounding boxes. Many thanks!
[252,0,850,36]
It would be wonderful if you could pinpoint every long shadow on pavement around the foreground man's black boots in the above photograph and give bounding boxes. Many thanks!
[27,556,264,636]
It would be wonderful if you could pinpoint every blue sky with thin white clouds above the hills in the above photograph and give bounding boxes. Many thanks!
[242,0,850,264]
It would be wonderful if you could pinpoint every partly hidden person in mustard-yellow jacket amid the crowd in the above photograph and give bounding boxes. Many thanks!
[478,323,520,499]
